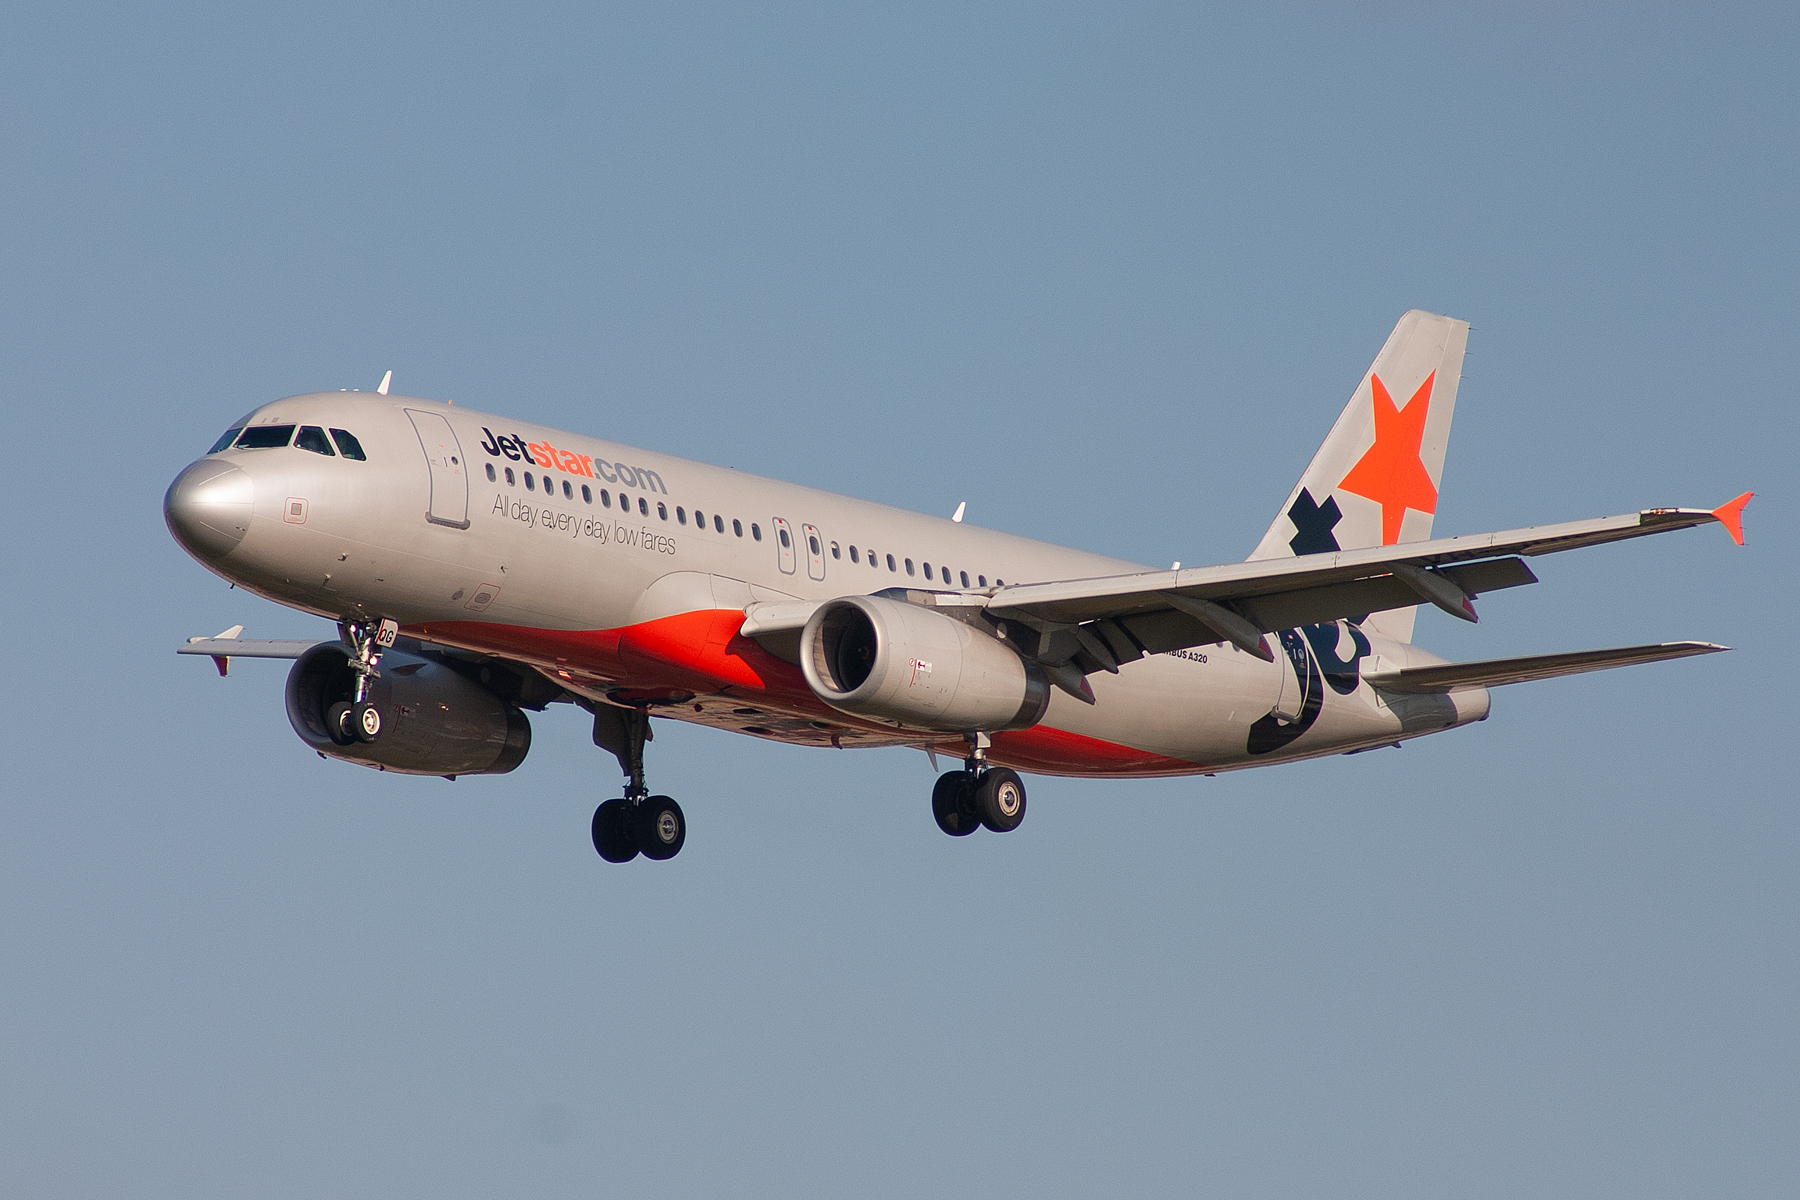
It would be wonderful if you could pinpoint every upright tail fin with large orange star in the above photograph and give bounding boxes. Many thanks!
[1249,309,1469,642]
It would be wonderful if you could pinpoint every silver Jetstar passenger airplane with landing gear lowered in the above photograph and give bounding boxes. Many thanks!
[164,309,1753,862]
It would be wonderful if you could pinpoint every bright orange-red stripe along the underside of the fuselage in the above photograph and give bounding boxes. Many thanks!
[415,608,1206,775]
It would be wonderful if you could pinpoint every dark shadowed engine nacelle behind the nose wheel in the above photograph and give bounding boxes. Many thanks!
[288,642,531,775]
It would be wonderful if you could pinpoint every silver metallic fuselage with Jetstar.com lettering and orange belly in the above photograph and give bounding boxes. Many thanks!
[166,392,1489,775]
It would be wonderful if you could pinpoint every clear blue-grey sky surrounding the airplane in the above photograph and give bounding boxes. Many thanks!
[0,4,1800,1198]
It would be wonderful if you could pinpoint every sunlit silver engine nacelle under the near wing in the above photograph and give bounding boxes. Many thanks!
[799,596,1049,732]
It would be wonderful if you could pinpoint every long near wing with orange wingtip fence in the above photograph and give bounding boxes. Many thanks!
[986,493,1750,673]
